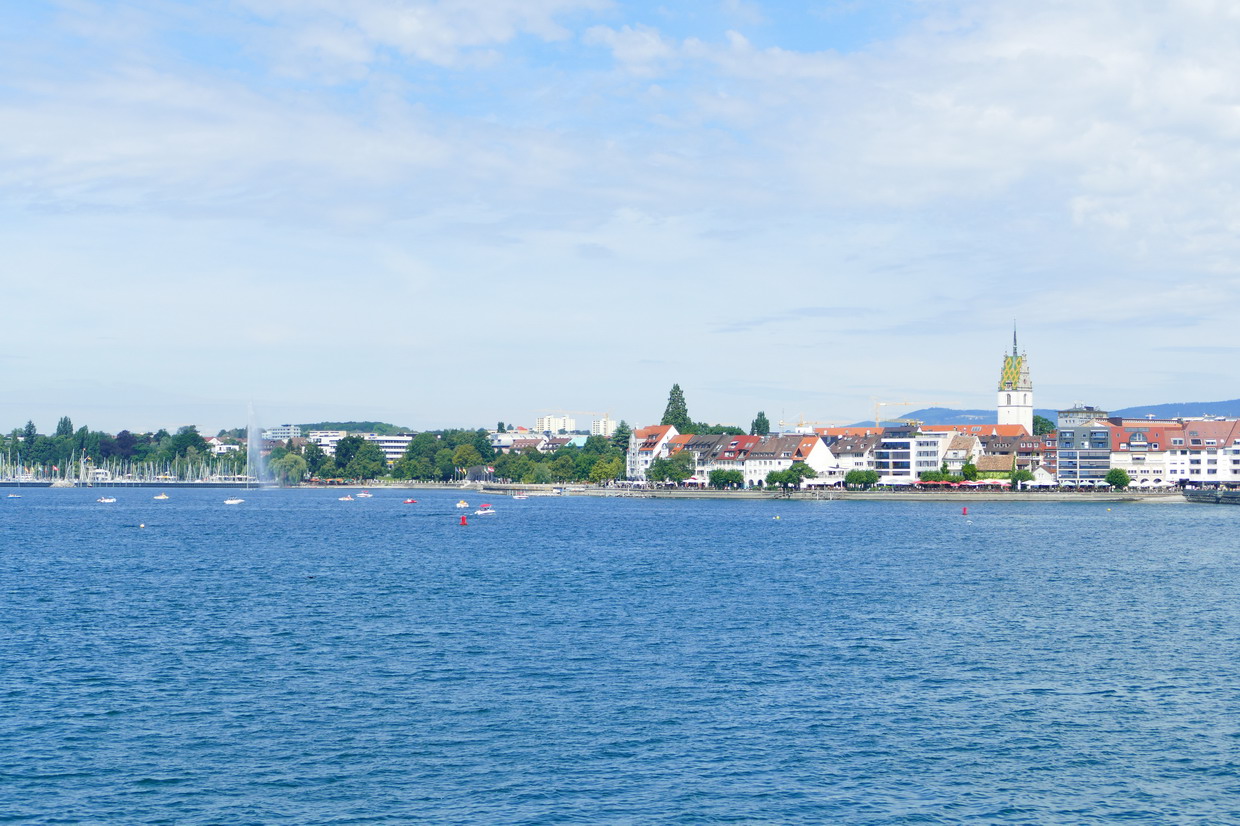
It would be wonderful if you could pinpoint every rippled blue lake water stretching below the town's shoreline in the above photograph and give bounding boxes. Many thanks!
[0,489,1240,825]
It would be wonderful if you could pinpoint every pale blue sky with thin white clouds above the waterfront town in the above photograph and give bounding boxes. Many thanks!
[0,0,1240,433]
